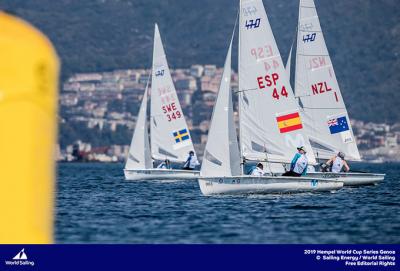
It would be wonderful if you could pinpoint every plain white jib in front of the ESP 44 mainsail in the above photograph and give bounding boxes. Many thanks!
[200,37,240,176]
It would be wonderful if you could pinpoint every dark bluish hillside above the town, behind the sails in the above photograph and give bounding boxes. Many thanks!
[0,0,400,122]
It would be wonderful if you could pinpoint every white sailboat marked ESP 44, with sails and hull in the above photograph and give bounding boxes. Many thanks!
[198,0,343,195]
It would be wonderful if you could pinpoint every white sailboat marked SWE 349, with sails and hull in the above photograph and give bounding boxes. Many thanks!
[124,24,199,180]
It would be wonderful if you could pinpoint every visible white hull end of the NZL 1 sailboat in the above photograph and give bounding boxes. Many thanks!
[307,172,385,186]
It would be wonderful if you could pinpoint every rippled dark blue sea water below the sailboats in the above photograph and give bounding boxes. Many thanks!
[55,164,400,243]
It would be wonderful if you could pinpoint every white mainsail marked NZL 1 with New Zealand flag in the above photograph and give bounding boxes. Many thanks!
[295,0,360,160]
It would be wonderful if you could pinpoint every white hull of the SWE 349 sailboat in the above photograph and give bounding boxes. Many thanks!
[124,168,200,181]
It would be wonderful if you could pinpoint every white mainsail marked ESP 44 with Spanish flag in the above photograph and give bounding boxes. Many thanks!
[239,0,315,163]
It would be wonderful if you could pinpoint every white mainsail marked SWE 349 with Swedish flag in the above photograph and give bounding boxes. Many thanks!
[150,24,194,162]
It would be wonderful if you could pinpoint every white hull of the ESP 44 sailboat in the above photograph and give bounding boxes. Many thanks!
[199,176,343,196]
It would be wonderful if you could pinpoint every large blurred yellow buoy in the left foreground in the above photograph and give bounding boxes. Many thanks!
[0,11,59,243]
